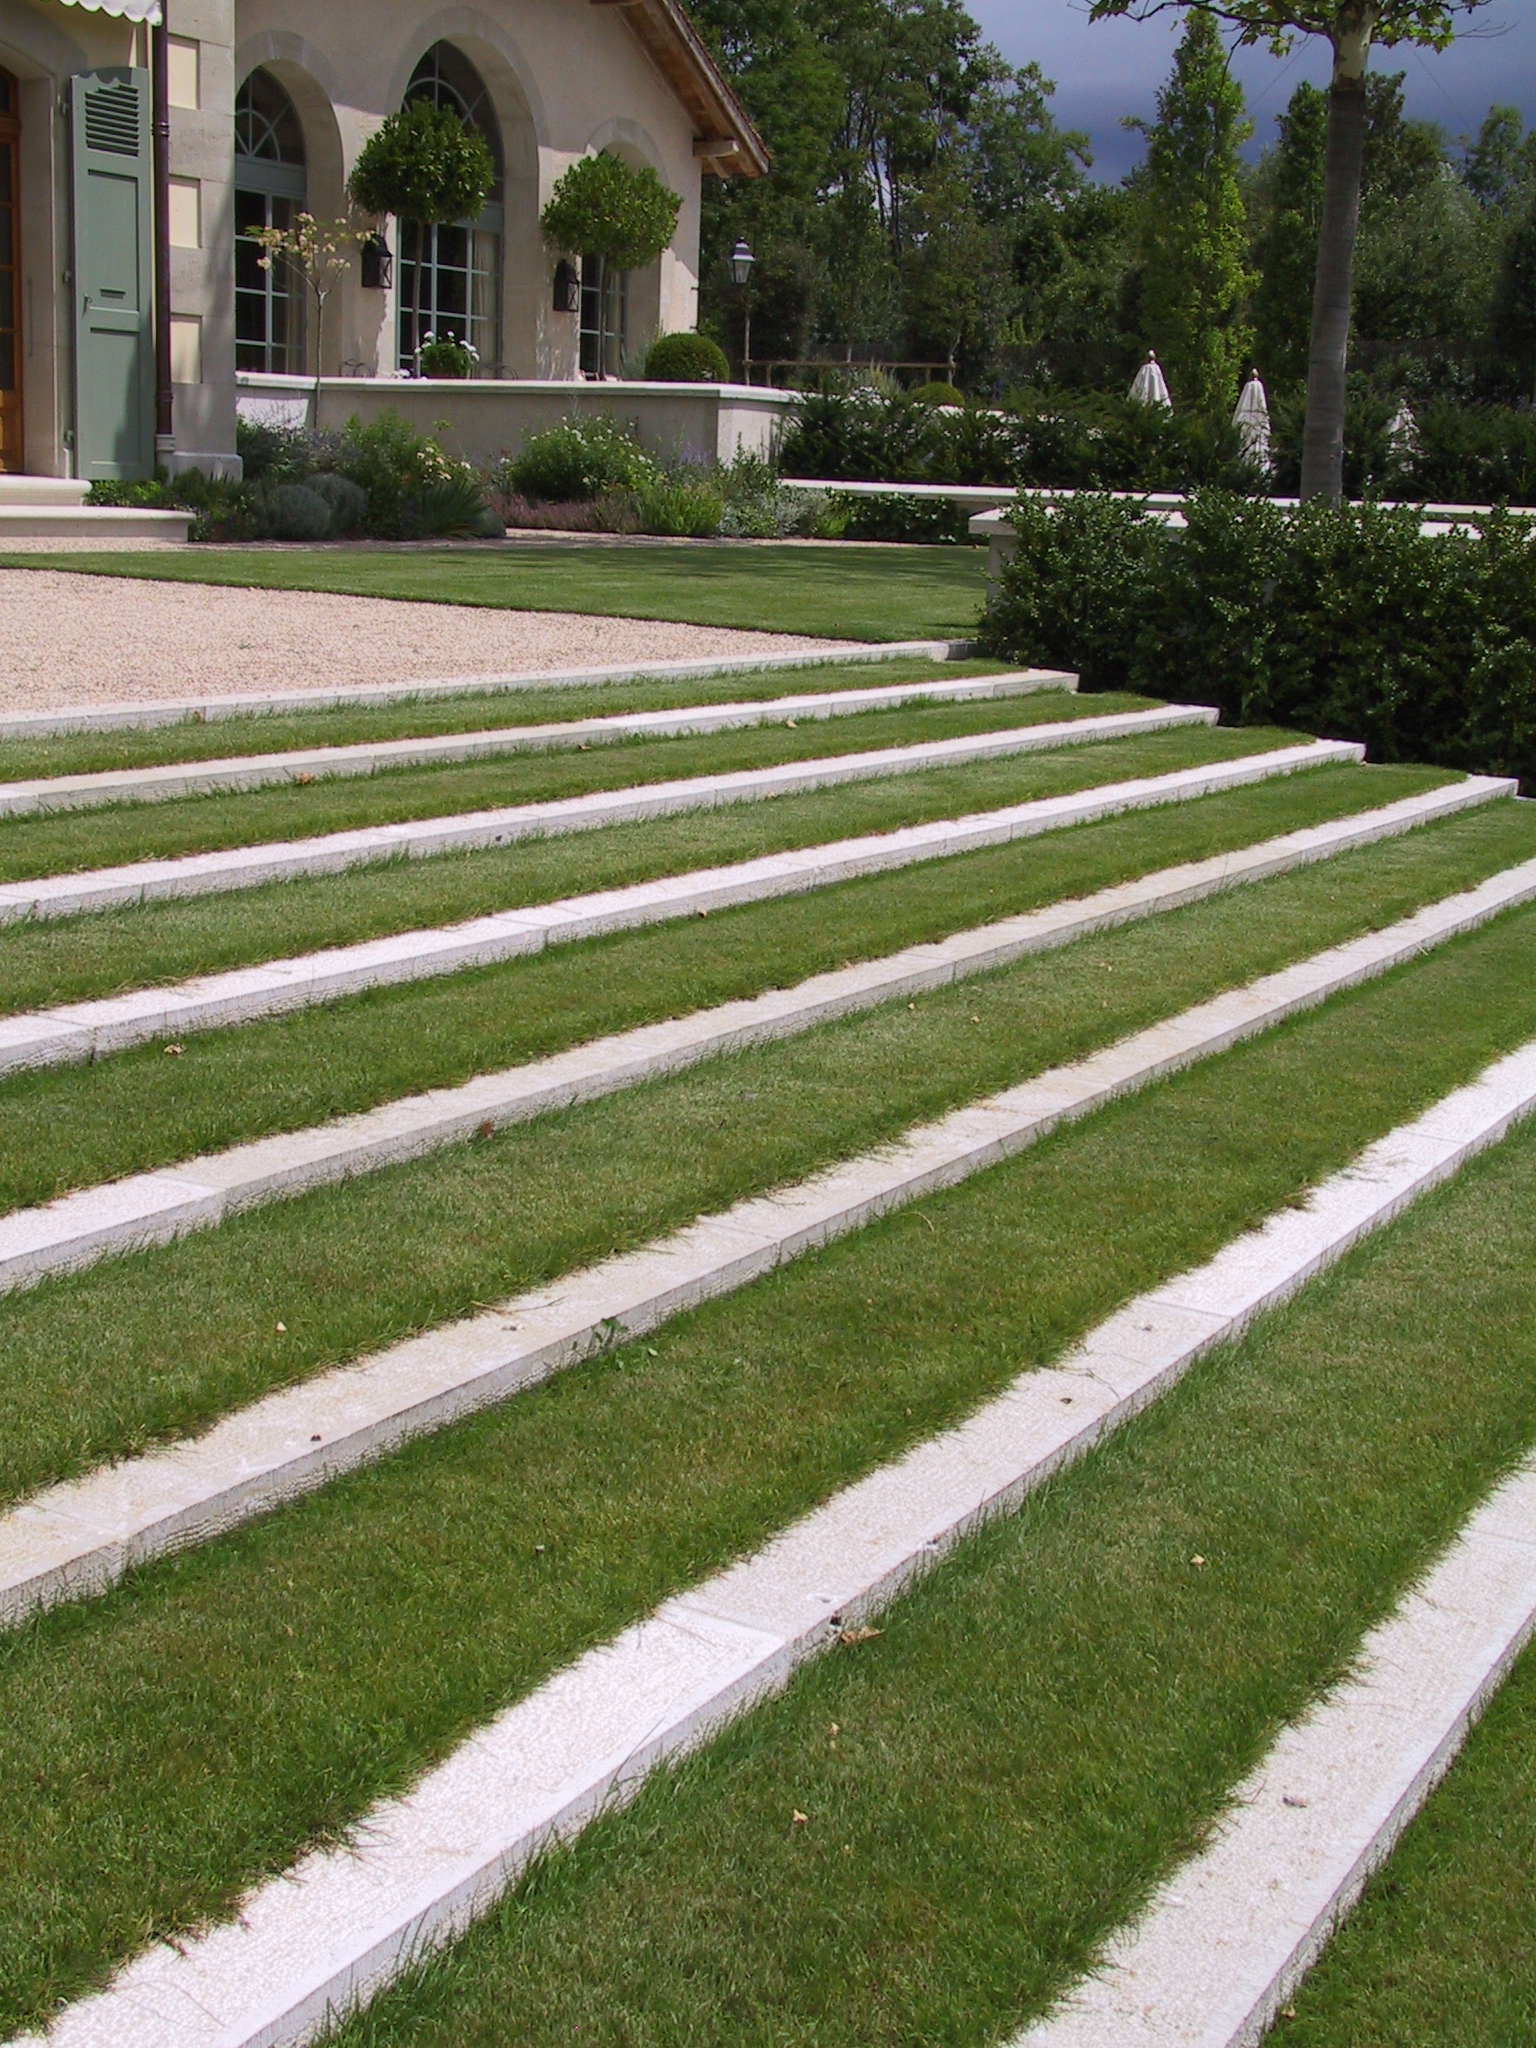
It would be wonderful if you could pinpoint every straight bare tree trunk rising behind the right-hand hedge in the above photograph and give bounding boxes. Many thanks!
[1300,8,1374,500]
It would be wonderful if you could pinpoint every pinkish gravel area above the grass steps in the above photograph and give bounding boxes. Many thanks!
[0,569,838,711]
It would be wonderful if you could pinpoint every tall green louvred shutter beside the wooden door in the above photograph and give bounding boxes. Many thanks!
[70,70,156,477]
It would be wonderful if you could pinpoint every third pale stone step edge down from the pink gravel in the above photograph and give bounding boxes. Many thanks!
[0,705,1217,924]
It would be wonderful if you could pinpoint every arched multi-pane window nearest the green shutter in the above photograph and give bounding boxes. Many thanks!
[236,72,305,375]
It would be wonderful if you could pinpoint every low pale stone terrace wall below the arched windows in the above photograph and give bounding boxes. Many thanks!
[236,373,795,467]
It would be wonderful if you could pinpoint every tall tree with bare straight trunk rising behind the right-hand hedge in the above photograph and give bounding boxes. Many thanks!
[1090,0,1487,498]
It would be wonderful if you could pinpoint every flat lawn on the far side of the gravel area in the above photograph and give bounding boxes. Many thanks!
[0,543,987,641]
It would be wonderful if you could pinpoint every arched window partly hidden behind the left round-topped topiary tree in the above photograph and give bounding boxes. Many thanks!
[399,43,504,377]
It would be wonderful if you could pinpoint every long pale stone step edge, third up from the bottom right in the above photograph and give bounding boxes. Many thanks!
[0,839,1536,1626]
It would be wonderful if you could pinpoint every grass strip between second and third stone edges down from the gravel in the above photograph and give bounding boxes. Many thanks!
[0,692,1138,883]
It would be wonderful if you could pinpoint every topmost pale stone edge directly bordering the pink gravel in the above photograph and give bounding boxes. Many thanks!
[0,641,975,739]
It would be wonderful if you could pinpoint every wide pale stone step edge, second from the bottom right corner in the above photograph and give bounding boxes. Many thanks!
[14,1044,1536,2048]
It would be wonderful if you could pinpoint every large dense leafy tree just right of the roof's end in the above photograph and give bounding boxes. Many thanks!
[692,0,1087,387]
